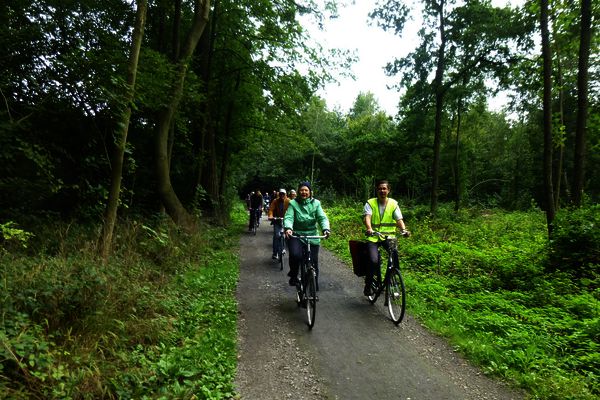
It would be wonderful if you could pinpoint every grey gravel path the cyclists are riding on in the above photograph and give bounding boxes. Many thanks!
[236,220,524,400]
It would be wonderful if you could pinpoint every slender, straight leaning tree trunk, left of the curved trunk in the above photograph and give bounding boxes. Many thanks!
[100,0,148,262]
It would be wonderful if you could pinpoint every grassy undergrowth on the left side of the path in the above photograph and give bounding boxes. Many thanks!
[0,210,243,399]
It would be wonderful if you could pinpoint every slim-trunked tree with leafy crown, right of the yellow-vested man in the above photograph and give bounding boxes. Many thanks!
[372,0,521,214]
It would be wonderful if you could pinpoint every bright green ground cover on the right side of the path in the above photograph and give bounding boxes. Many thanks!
[325,204,600,399]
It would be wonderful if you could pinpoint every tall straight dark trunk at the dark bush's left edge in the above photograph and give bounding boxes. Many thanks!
[540,0,555,236]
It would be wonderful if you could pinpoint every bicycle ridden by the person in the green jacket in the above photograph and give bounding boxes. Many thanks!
[294,235,327,329]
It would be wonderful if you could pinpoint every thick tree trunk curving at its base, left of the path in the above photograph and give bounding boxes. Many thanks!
[155,0,210,230]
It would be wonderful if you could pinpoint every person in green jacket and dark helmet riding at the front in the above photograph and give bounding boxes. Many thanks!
[283,182,330,290]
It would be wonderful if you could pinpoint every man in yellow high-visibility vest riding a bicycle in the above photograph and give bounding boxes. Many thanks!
[363,180,410,296]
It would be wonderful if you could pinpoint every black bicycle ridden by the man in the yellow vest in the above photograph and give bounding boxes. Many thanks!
[367,231,410,325]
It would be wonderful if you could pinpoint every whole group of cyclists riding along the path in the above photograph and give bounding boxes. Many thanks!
[246,180,410,296]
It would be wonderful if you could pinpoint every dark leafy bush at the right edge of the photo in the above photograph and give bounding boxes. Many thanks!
[547,205,600,278]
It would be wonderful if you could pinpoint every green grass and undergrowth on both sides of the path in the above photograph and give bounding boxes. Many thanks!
[0,204,600,399]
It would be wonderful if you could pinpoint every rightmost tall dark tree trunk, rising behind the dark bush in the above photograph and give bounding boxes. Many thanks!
[573,0,592,207]
